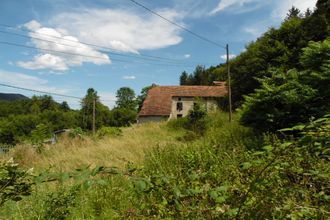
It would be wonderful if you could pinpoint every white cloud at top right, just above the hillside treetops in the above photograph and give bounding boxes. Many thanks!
[272,0,317,20]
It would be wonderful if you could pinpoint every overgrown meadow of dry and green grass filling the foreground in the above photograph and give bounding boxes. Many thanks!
[0,112,330,219]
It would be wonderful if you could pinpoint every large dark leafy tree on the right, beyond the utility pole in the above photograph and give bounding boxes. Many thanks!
[240,40,330,132]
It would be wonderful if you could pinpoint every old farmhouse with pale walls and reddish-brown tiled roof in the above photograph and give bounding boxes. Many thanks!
[138,82,227,123]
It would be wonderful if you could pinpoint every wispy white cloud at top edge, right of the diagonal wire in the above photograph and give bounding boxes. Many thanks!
[209,0,267,15]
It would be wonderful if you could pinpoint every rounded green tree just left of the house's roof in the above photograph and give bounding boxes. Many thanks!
[116,87,137,111]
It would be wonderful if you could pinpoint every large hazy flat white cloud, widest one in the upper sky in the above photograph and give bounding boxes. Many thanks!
[51,9,182,53]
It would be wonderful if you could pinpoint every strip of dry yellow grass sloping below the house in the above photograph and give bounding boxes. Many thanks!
[2,123,180,171]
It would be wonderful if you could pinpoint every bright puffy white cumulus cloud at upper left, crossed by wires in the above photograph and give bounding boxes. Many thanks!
[17,20,111,71]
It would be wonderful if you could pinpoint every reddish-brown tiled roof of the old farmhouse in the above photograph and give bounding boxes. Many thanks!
[139,83,227,116]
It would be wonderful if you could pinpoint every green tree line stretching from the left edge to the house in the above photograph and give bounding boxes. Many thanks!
[0,87,149,145]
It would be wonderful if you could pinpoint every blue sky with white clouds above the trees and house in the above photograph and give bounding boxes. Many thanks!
[0,0,316,109]
